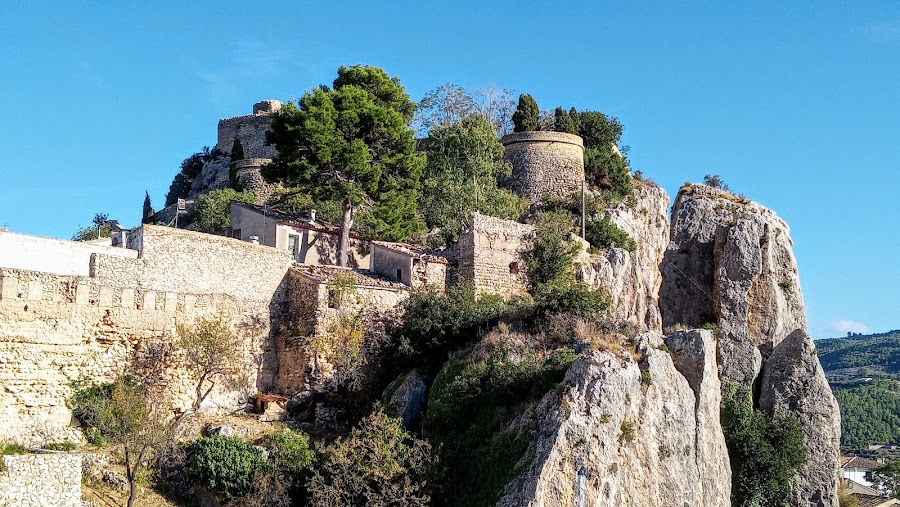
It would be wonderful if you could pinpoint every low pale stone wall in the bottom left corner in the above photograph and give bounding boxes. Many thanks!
[0,454,82,507]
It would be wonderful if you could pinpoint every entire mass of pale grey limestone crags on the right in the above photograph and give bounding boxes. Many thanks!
[500,185,840,507]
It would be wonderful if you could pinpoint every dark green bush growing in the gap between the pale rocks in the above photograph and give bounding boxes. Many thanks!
[721,384,807,507]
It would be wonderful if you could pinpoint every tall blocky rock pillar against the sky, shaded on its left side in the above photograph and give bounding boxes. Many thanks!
[660,185,806,383]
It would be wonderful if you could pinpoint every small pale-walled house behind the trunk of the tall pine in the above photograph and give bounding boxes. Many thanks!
[230,202,372,269]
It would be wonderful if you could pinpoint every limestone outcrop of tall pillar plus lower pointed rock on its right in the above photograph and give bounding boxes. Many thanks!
[660,185,840,507]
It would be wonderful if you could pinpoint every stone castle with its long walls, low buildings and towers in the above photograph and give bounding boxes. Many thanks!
[0,101,584,444]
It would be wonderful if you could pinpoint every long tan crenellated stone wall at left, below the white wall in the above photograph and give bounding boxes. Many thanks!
[0,225,292,445]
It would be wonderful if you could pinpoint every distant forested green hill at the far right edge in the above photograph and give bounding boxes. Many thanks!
[816,330,900,453]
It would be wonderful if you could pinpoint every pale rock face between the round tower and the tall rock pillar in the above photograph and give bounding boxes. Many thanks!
[577,183,669,332]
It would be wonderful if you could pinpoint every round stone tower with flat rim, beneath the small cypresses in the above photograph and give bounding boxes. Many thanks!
[500,131,584,201]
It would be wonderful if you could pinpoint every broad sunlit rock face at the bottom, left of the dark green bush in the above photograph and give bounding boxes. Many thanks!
[498,333,731,507]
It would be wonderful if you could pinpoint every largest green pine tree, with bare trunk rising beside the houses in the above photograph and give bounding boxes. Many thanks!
[262,65,425,265]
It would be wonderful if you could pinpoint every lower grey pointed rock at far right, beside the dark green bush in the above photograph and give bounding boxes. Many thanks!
[759,330,841,507]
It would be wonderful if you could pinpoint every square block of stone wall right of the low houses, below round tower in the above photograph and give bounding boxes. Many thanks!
[456,213,534,297]
